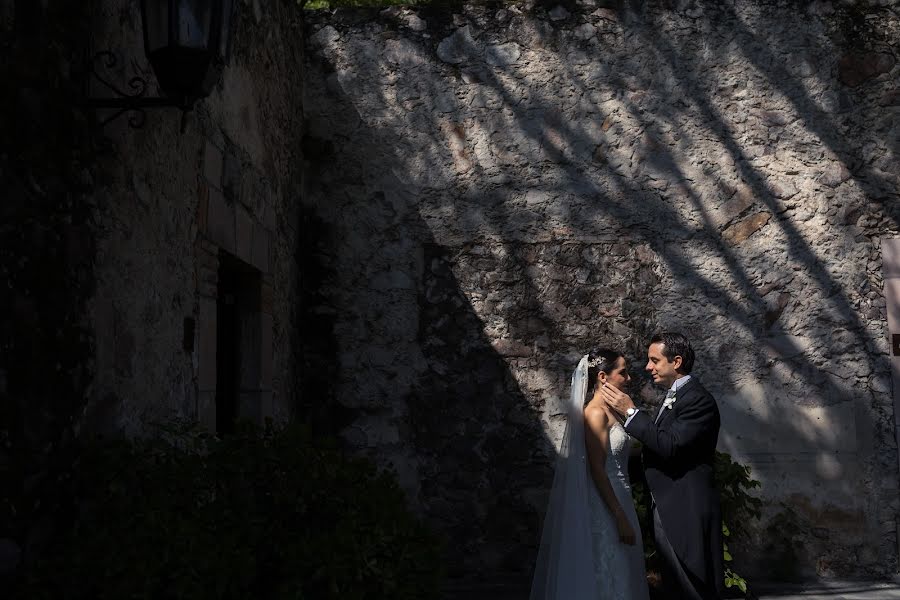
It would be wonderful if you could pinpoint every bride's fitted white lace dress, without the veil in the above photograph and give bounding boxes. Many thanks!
[585,423,650,600]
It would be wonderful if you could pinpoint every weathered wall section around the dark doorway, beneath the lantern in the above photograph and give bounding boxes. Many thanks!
[88,1,302,433]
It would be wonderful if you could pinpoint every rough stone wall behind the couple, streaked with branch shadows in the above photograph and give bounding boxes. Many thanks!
[304,0,900,581]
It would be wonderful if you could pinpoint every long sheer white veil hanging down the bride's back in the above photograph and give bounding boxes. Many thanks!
[530,356,597,600]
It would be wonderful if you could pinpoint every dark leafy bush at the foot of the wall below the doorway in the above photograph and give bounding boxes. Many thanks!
[19,426,440,600]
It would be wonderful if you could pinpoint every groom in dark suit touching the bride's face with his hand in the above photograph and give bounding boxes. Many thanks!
[601,333,723,600]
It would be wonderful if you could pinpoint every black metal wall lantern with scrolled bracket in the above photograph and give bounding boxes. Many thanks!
[85,0,234,132]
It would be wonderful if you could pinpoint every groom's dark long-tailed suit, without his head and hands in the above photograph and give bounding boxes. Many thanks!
[626,377,723,600]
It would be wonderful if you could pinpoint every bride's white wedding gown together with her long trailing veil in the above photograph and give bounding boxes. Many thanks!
[530,356,649,600]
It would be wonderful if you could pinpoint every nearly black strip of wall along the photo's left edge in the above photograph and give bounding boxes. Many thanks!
[0,1,98,589]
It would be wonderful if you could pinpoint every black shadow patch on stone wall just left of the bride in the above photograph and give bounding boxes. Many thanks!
[407,244,552,578]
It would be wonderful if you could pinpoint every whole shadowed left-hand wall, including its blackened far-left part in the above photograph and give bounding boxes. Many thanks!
[0,0,303,581]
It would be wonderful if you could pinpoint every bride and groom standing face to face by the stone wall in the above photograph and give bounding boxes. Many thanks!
[531,333,723,600]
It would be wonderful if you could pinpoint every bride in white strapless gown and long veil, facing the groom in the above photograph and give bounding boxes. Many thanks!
[530,349,649,600]
